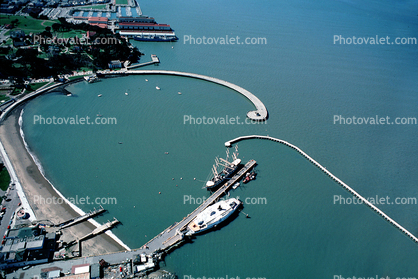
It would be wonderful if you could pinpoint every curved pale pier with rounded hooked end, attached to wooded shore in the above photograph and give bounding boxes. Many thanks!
[97,69,268,121]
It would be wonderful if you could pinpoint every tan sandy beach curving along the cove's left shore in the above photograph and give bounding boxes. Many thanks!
[0,106,125,256]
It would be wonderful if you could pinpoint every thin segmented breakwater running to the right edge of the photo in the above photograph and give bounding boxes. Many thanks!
[225,135,418,243]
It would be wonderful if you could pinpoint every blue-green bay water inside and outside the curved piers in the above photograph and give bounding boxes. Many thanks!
[19,1,418,278]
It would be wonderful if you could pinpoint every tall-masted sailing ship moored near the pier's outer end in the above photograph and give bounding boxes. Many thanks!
[204,145,241,190]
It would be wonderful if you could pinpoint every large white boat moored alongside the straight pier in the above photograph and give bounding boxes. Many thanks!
[186,198,241,235]
